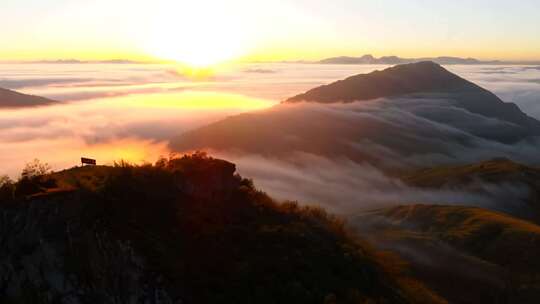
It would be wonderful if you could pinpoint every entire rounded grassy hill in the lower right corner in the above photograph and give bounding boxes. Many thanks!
[351,205,540,303]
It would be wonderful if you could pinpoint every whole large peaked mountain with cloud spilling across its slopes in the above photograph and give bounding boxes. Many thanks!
[170,62,540,169]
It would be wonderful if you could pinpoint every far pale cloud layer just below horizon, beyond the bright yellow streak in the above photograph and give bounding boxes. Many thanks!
[0,63,540,118]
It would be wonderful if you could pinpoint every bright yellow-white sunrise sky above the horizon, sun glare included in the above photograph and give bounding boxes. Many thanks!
[0,0,540,65]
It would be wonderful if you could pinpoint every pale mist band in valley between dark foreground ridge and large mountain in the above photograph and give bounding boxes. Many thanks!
[212,152,529,216]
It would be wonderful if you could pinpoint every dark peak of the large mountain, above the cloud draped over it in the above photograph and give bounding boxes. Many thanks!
[286,61,540,134]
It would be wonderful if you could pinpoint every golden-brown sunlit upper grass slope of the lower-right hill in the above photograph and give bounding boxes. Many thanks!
[382,205,540,266]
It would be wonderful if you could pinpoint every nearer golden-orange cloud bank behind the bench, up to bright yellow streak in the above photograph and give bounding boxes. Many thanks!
[0,92,270,178]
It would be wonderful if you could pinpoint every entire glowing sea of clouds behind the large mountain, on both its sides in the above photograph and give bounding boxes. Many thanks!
[0,63,540,175]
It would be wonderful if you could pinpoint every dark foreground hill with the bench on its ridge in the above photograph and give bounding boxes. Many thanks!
[0,153,445,303]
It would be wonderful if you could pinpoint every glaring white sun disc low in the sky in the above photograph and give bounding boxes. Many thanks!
[145,1,250,67]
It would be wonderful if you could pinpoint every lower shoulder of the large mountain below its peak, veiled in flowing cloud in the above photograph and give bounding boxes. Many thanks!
[173,96,540,169]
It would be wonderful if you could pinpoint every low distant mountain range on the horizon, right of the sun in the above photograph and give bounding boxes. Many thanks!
[318,55,502,64]
